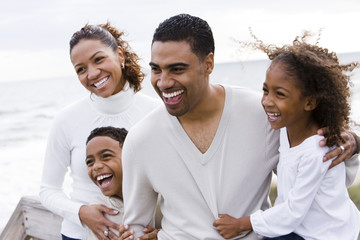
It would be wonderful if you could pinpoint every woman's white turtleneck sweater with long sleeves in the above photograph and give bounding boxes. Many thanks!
[40,85,161,239]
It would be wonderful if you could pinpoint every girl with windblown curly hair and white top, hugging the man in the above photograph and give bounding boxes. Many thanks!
[216,32,360,240]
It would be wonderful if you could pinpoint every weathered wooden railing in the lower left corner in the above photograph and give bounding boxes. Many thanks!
[0,196,62,240]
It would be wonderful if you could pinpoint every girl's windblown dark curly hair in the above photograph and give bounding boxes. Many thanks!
[239,29,359,146]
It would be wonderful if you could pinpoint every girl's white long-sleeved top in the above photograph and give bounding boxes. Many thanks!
[250,128,360,240]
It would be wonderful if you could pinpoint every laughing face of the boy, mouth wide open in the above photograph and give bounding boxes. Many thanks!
[86,136,122,198]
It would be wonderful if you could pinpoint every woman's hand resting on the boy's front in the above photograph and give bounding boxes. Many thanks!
[79,204,120,240]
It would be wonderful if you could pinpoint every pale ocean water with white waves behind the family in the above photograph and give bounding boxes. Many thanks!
[0,52,360,229]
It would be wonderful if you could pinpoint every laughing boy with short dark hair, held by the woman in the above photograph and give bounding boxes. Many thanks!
[85,127,157,240]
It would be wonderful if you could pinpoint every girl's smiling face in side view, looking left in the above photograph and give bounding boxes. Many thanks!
[261,62,309,131]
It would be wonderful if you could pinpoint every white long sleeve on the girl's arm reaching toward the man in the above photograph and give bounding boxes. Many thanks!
[250,150,331,237]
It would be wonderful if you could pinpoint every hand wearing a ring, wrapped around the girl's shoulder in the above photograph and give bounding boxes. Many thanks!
[317,128,360,168]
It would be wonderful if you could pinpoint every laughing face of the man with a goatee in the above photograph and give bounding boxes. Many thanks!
[150,41,213,117]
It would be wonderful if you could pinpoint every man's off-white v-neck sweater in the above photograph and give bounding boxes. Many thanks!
[123,87,279,240]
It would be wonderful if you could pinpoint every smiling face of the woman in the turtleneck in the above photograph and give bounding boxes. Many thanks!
[70,39,125,98]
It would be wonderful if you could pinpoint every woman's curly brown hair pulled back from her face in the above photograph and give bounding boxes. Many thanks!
[70,22,145,92]
